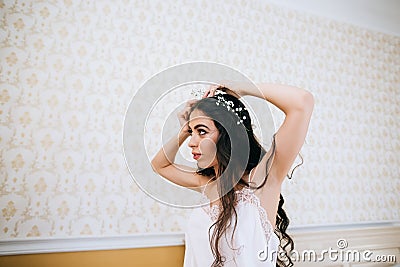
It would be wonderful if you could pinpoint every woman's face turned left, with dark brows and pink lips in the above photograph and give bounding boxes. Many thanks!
[188,109,219,170]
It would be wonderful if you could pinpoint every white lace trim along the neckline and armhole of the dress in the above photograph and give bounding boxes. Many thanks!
[203,187,273,242]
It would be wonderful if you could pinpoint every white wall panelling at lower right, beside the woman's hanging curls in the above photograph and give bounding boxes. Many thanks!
[290,222,400,267]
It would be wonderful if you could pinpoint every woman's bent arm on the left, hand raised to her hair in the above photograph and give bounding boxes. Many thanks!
[151,101,202,191]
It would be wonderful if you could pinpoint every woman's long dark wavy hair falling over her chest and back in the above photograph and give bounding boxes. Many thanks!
[191,87,294,267]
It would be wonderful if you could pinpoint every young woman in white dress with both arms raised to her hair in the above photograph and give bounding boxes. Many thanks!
[152,83,314,267]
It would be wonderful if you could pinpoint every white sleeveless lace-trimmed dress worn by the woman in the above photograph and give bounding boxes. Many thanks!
[184,171,279,267]
